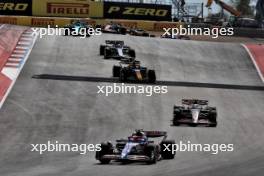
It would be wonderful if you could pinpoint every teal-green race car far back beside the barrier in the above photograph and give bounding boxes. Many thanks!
[64,20,93,37]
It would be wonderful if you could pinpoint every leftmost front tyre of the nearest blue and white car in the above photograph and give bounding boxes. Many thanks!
[95,143,113,164]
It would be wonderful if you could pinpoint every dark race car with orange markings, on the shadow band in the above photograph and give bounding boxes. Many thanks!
[113,60,156,83]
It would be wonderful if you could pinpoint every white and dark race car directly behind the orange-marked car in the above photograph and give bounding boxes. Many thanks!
[100,40,136,60]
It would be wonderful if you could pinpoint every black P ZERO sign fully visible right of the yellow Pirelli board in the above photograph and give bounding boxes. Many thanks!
[104,2,171,21]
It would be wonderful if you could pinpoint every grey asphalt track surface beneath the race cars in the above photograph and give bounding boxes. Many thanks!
[0,34,264,176]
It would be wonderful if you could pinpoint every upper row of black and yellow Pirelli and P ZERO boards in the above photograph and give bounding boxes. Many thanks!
[0,0,172,21]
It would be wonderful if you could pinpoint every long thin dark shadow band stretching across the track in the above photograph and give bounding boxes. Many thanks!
[32,74,264,91]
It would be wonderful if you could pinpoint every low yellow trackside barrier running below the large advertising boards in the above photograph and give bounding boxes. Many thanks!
[0,16,183,31]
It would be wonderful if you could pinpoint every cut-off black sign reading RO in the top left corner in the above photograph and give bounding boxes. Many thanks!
[0,0,32,16]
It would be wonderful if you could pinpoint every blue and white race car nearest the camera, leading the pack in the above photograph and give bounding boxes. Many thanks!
[95,130,175,164]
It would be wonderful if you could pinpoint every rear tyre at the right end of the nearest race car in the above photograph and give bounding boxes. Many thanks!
[160,140,175,159]
